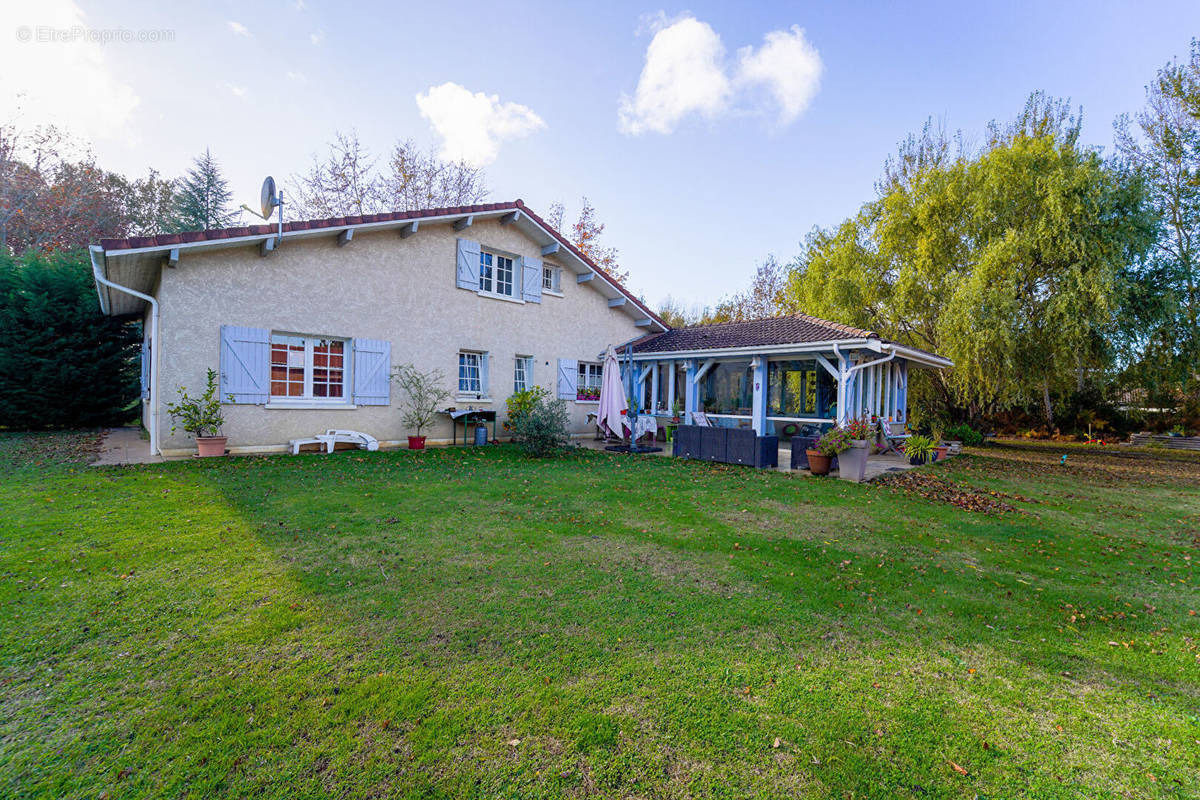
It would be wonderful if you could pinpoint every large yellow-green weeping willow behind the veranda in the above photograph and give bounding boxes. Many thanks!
[787,94,1152,425]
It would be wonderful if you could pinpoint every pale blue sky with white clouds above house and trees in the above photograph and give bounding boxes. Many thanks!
[0,0,1200,303]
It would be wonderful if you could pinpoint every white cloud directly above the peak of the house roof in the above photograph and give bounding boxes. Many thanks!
[416,83,546,166]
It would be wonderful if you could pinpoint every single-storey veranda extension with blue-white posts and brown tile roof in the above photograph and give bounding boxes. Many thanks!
[625,314,953,435]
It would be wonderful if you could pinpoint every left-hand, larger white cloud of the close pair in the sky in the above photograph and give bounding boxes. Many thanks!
[618,17,731,136]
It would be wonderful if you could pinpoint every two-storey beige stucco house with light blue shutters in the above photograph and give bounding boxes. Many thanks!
[91,200,668,456]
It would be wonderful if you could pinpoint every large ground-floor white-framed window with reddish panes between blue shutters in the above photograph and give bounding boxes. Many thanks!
[271,332,350,403]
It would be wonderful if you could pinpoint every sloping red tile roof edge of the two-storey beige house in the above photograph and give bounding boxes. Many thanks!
[100,198,670,327]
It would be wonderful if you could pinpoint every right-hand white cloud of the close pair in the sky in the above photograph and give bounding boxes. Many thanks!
[737,25,822,124]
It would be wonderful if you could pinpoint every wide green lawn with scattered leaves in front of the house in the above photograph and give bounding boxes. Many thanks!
[0,434,1200,799]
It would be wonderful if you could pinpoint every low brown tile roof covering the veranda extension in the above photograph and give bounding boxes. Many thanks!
[634,314,877,353]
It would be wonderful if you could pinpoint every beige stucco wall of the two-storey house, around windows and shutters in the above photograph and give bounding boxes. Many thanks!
[158,221,646,455]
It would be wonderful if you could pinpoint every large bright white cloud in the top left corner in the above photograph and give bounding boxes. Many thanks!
[0,0,140,142]
